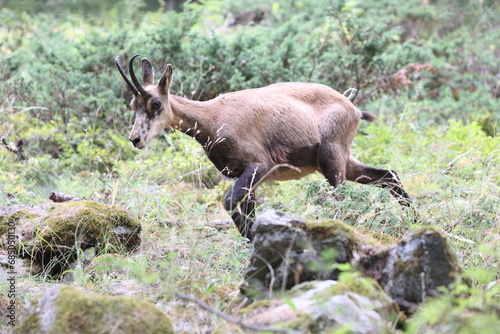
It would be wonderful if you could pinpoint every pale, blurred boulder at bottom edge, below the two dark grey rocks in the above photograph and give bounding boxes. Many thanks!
[221,278,399,333]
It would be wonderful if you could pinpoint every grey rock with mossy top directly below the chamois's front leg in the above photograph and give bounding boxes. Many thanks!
[241,210,362,299]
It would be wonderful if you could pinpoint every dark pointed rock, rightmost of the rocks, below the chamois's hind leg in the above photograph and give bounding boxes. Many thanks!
[358,226,461,314]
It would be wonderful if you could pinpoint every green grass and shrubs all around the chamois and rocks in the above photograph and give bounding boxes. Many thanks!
[0,0,500,333]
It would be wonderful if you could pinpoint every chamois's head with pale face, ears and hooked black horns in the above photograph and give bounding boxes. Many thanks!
[115,55,173,149]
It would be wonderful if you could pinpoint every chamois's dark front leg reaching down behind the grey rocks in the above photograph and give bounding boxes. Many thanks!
[224,166,267,241]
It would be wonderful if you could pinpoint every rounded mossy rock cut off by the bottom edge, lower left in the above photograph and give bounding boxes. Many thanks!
[14,286,173,334]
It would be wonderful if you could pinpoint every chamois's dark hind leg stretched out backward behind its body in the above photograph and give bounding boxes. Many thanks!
[346,157,412,207]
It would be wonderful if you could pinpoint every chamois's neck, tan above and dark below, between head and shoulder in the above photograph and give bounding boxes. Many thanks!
[169,95,213,144]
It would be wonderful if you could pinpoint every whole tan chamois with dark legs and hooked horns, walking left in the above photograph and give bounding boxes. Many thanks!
[115,55,411,240]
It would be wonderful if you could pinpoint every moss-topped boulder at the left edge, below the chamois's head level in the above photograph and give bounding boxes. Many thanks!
[0,201,141,275]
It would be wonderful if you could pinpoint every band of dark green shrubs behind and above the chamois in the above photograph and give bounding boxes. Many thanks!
[0,0,499,175]
